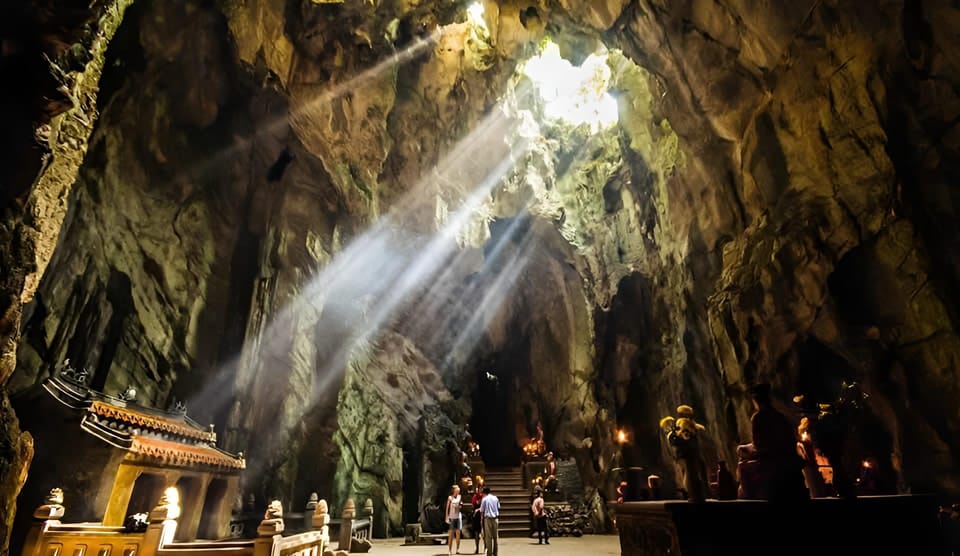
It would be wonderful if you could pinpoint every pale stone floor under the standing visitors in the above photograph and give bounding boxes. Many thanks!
[370,535,620,556]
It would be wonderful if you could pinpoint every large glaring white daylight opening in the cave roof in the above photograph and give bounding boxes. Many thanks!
[523,41,618,132]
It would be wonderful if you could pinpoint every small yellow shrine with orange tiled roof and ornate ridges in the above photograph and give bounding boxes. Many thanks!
[18,368,246,540]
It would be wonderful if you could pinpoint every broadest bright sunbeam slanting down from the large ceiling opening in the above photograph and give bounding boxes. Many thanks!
[184,102,529,484]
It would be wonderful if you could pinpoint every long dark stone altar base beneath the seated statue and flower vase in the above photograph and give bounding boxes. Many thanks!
[610,496,947,556]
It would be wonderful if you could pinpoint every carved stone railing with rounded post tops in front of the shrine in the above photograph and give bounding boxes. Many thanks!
[22,489,330,556]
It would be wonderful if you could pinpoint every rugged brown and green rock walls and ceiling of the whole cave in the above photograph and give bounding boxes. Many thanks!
[0,0,960,537]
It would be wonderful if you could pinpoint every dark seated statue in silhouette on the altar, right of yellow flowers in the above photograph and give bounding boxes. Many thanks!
[737,384,809,501]
